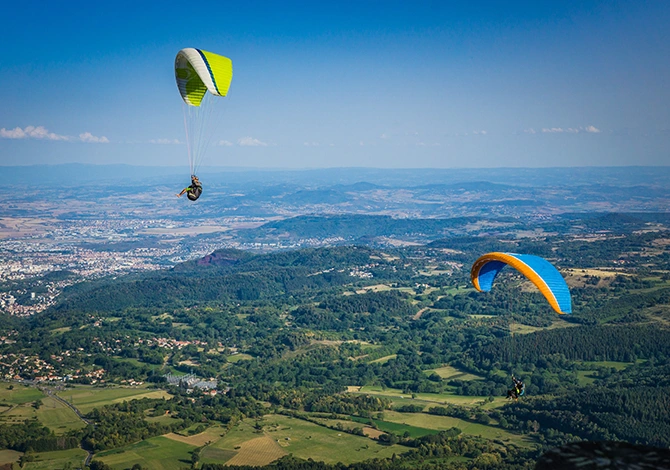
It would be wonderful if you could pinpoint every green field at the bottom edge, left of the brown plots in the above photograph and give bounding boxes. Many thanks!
[93,436,196,470]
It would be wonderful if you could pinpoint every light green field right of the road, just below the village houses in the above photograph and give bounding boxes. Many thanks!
[58,385,171,413]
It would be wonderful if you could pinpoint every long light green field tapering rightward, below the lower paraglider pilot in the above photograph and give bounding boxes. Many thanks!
[380,411,534,446]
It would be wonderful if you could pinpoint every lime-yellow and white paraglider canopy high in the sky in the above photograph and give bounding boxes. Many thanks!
[174,47,233,106]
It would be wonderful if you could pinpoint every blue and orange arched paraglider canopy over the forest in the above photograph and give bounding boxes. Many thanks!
[470,252,572,314]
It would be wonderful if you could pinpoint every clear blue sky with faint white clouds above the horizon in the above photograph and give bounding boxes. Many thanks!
[0,0,670,168]
